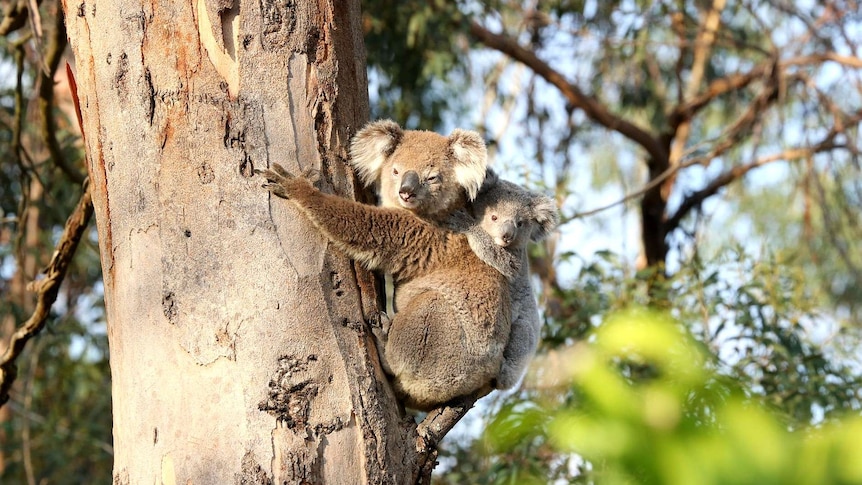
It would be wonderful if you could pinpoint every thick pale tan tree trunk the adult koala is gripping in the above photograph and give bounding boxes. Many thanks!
[64,0,418,484]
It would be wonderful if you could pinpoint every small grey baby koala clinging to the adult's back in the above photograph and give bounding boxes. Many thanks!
[449,169,559,389]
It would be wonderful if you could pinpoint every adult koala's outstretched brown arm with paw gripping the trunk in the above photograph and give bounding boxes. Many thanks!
[256,164,447,278]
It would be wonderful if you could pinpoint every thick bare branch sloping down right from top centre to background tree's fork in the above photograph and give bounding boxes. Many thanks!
[470,21,667,160]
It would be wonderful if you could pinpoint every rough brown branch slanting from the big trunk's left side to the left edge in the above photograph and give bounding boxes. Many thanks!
[0,182,93,406]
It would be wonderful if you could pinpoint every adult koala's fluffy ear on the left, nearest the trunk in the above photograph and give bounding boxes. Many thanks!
[350,120,404,186]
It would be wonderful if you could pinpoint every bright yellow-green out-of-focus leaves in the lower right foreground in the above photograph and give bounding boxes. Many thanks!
[483,310,862,485]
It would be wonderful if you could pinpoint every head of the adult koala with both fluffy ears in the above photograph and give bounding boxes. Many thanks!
[350,120,488,223]
